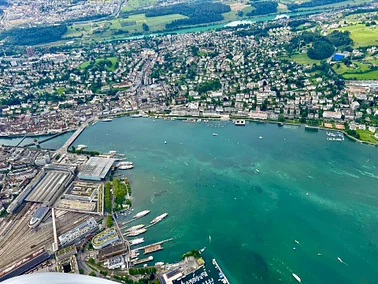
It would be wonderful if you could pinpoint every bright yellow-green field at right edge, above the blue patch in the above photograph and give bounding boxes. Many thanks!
[338,24,378,47]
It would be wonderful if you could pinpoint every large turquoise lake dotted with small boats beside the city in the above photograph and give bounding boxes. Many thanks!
[67,117,378,284]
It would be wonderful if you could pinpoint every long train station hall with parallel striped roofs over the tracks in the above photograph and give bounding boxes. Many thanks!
[25,164,76,206]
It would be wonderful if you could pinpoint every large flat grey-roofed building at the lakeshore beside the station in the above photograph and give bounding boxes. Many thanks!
[78,157,116,181]
